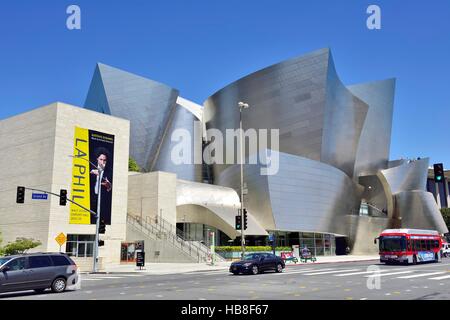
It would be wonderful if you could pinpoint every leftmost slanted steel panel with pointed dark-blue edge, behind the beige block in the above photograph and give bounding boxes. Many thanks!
[84,64,178,171]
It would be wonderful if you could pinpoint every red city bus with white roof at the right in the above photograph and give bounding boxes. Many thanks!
[375,229,442,264]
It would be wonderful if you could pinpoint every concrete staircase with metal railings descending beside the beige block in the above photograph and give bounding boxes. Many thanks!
[127,214,225,263]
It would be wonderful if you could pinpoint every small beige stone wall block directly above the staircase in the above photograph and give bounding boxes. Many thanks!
[128,171,177,225]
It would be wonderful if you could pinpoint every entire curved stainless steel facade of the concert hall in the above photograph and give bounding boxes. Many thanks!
[85,49,448,253]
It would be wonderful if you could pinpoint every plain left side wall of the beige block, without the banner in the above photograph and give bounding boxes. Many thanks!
[0,105,57,251]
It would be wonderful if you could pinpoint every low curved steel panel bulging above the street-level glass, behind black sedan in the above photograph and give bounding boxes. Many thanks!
[217,153,362,234]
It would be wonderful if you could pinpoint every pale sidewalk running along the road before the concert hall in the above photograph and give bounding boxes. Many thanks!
[85,255,380,275]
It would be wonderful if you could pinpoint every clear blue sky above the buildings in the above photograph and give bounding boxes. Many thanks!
[0,0,450,168]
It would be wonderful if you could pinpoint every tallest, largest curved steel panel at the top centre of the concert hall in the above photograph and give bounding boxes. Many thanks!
[204,49,368,181]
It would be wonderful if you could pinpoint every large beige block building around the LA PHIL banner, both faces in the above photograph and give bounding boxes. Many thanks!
[0,103,130,264]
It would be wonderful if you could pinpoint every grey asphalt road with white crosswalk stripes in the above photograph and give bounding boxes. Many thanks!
[0,259,450,300]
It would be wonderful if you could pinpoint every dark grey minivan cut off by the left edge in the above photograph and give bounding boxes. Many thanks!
[0,253,80,293]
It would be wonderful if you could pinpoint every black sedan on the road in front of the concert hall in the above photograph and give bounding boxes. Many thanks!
[230,253,285,275]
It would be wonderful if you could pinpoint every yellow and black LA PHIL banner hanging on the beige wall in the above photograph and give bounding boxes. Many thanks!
[70,127,114,225]
